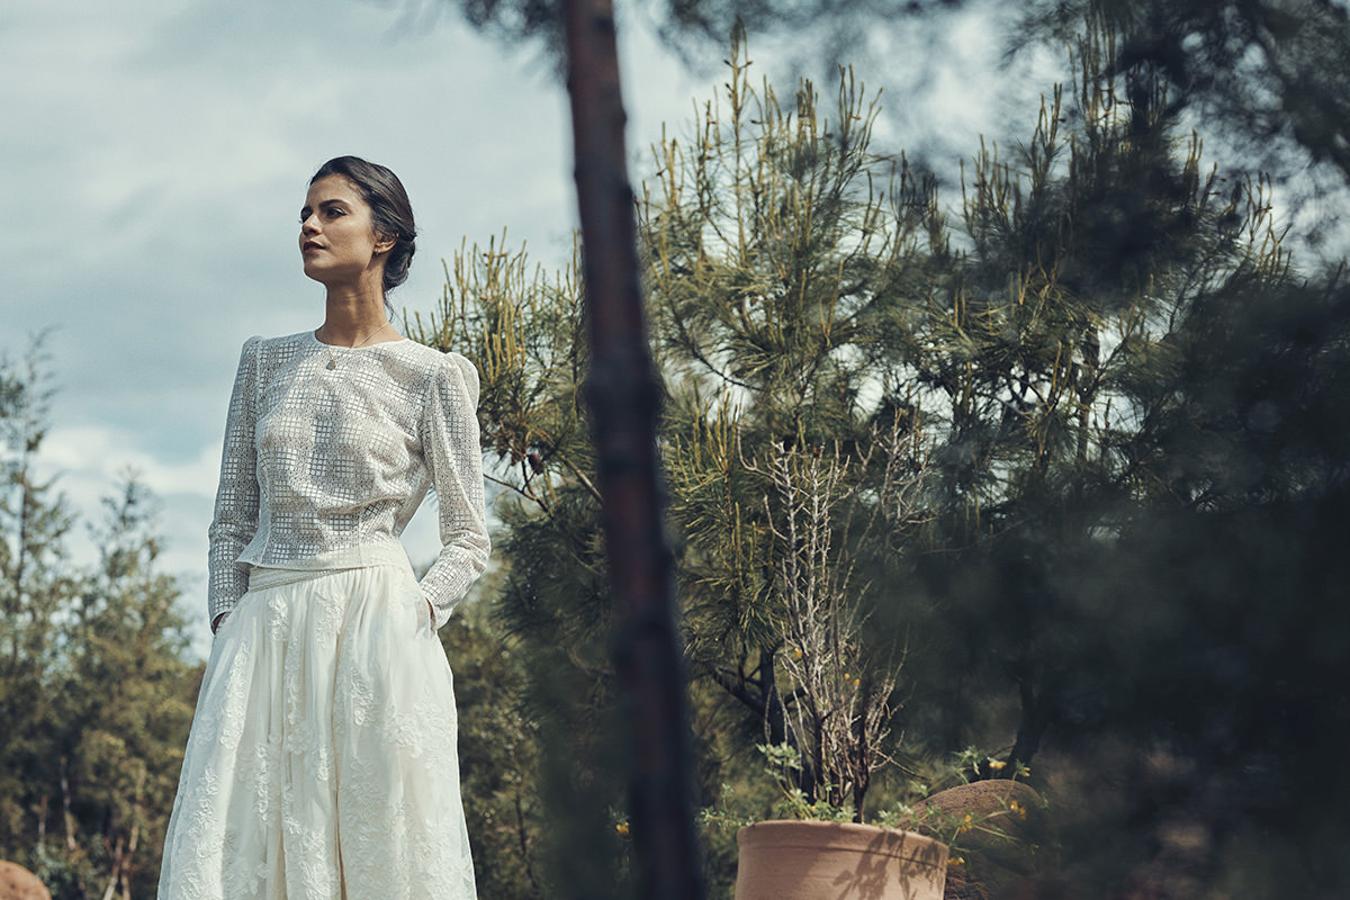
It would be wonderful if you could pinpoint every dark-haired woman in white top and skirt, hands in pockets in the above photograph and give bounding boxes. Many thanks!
[158,157,490,900]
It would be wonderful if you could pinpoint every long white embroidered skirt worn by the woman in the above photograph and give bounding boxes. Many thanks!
[158,549,477,900]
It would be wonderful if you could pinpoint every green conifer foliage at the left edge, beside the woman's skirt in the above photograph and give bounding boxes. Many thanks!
[0,334,200,897]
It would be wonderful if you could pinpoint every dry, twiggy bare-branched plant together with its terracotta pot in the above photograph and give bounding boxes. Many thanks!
[711,426,949,900]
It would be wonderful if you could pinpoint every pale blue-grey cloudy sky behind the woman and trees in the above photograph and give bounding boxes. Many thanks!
[0,0,1044,654]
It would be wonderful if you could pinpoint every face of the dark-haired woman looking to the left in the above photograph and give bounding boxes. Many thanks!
[300,175,394,285]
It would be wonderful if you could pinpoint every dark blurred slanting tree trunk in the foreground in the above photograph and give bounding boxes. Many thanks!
[564,0,706,900]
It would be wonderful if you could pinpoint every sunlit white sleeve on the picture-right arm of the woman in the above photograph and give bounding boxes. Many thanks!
[420,354,491,629]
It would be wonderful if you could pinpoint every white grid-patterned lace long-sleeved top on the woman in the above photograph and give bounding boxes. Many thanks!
[207,331,491,629]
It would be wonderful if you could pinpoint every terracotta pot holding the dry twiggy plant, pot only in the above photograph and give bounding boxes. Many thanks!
[736,819,948,900]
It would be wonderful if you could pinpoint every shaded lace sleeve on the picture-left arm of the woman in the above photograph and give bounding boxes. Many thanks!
[207,335,262,631]
